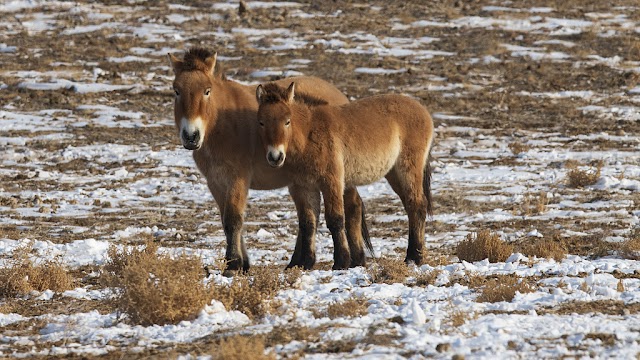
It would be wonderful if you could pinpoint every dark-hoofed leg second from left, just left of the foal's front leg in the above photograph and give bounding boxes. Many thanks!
[287,185,320,270]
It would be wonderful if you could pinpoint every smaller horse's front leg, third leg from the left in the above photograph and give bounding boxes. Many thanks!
[322,177,351,270]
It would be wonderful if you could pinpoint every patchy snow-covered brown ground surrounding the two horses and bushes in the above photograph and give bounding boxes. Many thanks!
[0,0,640,359]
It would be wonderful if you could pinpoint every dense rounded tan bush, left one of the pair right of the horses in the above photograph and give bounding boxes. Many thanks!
[456,230,513,263]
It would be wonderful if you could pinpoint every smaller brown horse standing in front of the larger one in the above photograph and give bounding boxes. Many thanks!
[256,82,433,269]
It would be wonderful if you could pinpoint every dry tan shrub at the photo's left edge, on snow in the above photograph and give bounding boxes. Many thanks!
[0,246,73,298]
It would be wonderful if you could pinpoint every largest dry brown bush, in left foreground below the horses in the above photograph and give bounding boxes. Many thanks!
[104,241,212,326]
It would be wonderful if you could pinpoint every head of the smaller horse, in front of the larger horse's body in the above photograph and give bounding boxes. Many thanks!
[256,83,295,167]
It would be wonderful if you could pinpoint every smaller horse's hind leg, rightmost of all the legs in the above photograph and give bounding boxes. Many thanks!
[387,163,427,265]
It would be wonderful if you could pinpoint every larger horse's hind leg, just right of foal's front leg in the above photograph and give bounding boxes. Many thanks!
[344,186,366,267]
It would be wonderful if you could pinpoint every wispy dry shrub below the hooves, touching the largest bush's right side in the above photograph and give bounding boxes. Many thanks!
[212,266,302,319]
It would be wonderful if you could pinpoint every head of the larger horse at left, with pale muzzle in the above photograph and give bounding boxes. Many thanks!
[169,48,219,150]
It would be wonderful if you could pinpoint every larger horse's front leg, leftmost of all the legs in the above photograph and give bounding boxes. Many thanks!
[222,178,249,276]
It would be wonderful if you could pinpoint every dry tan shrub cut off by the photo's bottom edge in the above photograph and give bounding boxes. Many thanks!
[210,335,276,360]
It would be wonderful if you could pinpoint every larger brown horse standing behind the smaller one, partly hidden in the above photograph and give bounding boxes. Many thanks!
[169,48,372,275]
